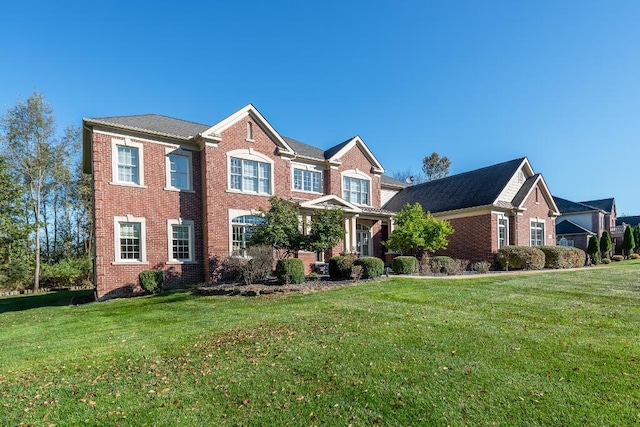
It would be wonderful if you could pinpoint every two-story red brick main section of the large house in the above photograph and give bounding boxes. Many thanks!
[83,105,403,298]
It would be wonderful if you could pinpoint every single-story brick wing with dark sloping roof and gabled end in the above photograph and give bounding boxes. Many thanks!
[384,158,558,262]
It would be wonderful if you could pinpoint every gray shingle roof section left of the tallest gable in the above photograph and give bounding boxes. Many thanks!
[85,114,210,139]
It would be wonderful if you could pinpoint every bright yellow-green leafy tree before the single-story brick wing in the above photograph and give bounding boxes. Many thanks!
[385,203,454,257]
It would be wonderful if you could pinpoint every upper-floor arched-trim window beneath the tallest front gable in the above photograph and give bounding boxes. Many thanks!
[227,149,273,195]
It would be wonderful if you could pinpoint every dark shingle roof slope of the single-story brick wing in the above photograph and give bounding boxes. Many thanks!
[383,158,525,213]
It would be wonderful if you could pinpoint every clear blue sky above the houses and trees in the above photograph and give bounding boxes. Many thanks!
[0,0,640,215]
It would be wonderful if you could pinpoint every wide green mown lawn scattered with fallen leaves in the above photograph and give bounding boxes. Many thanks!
[0,261,640,426]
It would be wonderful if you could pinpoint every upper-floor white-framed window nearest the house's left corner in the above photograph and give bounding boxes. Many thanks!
[111,138,144,187]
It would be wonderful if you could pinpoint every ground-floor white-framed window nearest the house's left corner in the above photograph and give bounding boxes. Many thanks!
[114,215,147,264]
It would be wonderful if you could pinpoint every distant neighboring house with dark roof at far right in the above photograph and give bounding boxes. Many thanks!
[553,196,624,252]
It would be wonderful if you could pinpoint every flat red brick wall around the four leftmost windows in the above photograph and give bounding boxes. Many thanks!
[93,133,203,297]
